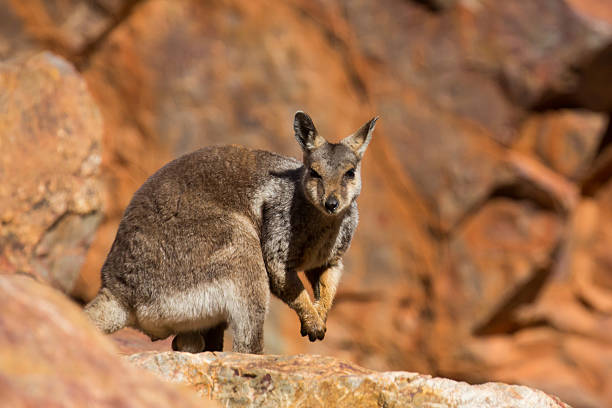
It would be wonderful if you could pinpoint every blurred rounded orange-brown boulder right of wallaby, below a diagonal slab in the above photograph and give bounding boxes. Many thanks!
[442,197,563,333]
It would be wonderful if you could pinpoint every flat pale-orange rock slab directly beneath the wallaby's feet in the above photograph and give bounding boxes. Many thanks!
[128,352,569,408]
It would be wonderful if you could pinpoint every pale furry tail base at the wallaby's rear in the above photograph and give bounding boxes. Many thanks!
[85,288,132,334]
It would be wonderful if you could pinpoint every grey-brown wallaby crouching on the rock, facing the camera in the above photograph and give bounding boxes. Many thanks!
[85,111,378,354]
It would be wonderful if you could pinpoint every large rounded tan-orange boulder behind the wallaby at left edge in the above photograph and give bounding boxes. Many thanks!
[0,53,102,292]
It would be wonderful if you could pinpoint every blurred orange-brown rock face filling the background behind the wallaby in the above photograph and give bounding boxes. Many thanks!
[0,0,612,407]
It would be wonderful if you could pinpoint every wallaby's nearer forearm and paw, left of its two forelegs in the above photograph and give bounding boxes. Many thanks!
[270,271,326,341]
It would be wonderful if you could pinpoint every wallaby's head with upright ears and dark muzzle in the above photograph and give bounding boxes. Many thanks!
[293,111,378,215]
